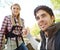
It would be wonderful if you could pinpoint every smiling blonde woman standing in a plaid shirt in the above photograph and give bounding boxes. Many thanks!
[1,3,28,50]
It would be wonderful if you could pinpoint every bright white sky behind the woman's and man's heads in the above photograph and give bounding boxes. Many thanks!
[0,0,53,28]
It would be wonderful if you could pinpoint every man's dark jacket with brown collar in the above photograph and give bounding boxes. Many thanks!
[40,23,60,50]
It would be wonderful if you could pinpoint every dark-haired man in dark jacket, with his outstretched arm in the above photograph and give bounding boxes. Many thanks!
[24,5,60,50]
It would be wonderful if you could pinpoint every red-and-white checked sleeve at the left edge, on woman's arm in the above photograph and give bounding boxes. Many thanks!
[0,16,8,47]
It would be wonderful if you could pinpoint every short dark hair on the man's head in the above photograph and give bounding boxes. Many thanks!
[34,5,54,16]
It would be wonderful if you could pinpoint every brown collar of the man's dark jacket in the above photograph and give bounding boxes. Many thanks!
[40,22,60,37]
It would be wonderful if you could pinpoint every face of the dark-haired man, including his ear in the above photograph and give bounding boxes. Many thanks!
[36,10,55,31]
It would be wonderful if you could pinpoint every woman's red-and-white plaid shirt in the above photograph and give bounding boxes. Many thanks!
[0,16,24,46]
